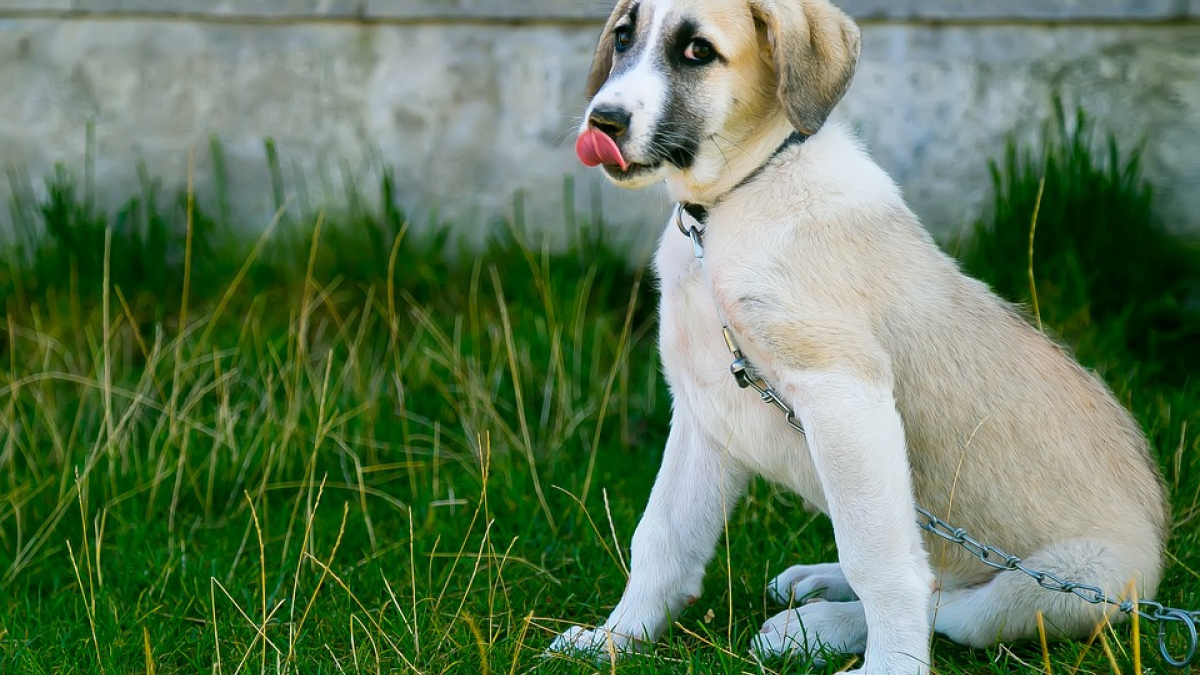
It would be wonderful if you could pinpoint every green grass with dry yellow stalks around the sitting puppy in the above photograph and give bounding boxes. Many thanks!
[0,111,1200,674]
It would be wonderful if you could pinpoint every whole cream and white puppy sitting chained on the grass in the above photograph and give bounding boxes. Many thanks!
[551,0,1169,674]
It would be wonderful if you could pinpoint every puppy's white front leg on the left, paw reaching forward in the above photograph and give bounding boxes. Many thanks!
[550,400,748,658]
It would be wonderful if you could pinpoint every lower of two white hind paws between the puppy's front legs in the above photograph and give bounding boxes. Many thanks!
[751,602,866,662]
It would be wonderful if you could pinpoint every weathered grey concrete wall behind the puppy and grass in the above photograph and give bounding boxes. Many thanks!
[0,0,1200,247]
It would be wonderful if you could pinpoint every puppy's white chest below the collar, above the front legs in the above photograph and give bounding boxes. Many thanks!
[656,226,826,510]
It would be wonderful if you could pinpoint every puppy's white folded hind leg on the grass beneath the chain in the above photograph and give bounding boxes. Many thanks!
[930,539,1160,647]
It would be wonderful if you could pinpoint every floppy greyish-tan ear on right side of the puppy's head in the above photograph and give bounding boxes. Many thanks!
[750,0,862,136]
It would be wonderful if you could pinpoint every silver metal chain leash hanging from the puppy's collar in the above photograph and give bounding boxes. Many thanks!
[676,207,1200,668]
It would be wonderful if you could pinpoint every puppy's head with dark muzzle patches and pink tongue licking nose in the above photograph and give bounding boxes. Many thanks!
[576,0,859,187]
